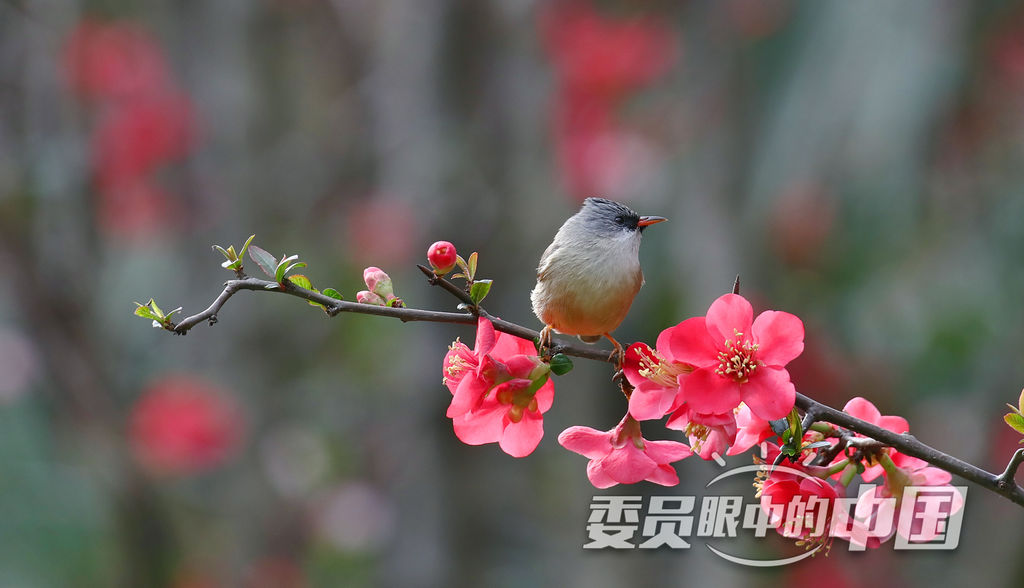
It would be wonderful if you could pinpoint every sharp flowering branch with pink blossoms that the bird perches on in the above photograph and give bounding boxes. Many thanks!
[135,238,1024,516]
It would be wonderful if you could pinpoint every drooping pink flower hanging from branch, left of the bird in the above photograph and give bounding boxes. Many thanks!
[443,317,555,457]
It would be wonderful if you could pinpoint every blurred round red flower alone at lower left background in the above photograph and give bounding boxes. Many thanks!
[129,375,243,474]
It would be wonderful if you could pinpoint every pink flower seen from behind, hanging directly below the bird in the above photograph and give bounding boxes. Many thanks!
[558,414,692,489]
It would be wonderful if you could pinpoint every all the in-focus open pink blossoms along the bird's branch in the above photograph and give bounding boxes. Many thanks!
[443,294,959,547]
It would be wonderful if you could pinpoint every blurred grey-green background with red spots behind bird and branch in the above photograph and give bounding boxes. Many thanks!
[0,0,1024,588]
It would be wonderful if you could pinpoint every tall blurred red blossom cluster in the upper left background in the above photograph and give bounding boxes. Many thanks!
[63,19,196,237]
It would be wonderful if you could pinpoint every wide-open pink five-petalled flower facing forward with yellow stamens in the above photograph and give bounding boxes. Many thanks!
[658,294,804,420]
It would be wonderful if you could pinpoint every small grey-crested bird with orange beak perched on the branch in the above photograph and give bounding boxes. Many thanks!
[529,198,667,364]
